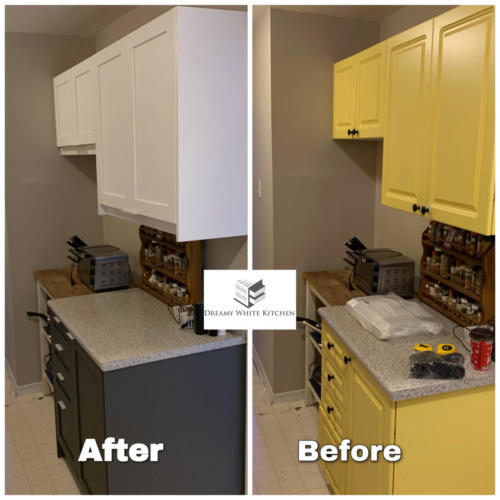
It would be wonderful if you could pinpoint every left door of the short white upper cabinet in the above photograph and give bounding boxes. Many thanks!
[54,70,76,147]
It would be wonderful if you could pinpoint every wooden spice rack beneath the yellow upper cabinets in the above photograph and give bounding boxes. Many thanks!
[419,224,495,326]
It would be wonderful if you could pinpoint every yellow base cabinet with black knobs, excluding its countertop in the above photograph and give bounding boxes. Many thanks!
[318,323,495,495]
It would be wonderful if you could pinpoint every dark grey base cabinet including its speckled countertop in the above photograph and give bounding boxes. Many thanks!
[48,289,246,494]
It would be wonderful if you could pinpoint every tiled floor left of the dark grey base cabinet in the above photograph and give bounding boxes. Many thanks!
[5,381,79,495]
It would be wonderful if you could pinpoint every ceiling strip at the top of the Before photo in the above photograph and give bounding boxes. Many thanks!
[273,5,403,22]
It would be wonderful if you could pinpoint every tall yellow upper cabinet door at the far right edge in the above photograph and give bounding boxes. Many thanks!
[426,6,495,234]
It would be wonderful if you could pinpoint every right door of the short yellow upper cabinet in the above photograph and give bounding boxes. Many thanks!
[356,42,386,139]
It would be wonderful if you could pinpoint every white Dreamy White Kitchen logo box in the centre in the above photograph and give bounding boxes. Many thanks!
[204,269,297,330]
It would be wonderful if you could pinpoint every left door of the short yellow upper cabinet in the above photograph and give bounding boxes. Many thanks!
[333,56,356,139]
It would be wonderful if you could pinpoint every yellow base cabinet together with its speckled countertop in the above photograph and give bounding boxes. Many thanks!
[318,305,495,494]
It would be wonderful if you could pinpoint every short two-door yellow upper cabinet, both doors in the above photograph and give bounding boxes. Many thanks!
[333,42,385,139]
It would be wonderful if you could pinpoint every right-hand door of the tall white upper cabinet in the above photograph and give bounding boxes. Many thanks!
[127,15,177,224]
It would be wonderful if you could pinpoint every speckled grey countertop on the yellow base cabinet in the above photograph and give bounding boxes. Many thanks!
[318,302,495,401]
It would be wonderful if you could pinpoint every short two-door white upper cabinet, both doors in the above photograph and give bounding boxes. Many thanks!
[54,58,97,154]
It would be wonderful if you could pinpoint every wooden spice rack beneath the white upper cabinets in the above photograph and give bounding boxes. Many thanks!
[139,225,202,305]
